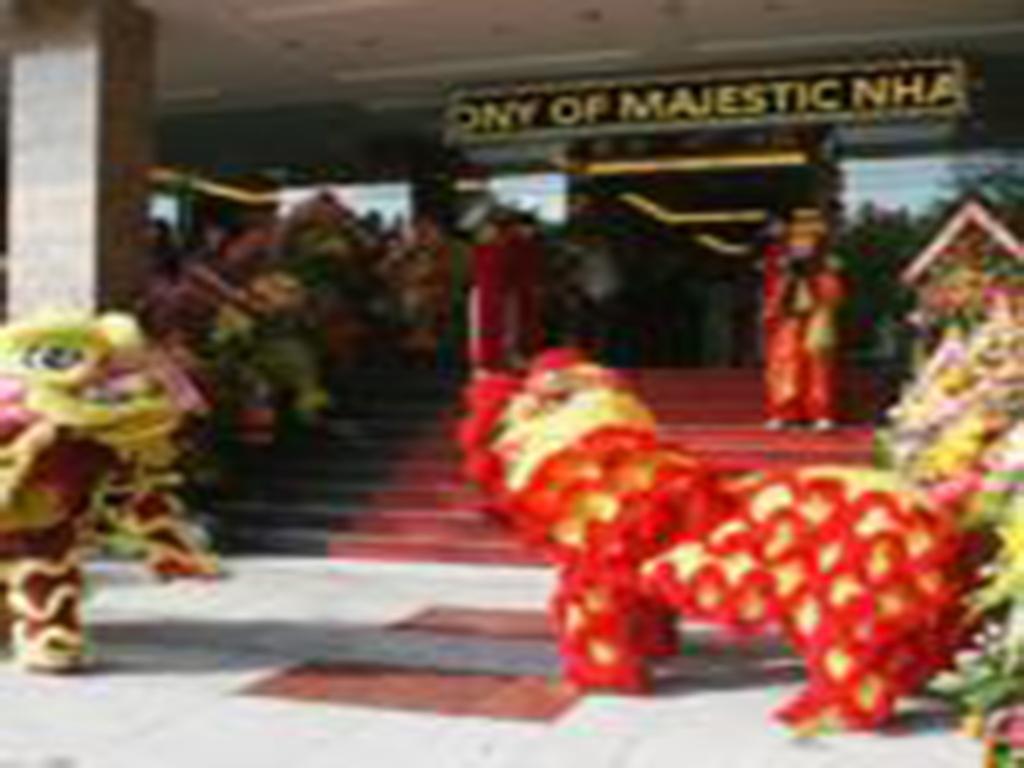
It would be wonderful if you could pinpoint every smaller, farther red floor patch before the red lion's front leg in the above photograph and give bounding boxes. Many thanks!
[391,605,553,640]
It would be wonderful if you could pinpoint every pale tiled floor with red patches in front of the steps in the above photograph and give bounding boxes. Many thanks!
[0,560,981,768]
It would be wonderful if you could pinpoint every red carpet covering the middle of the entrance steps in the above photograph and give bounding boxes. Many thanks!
[330,370,884,564]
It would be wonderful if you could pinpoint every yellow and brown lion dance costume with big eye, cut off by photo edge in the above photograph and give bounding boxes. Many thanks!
[0,314,217,672]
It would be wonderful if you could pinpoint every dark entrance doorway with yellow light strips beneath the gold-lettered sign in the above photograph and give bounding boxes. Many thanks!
[567,129,837,368]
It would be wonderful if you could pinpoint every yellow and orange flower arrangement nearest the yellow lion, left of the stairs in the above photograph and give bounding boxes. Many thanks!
[139,229,328,462]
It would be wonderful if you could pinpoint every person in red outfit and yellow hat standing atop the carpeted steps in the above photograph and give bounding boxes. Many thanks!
[763,212,845,430]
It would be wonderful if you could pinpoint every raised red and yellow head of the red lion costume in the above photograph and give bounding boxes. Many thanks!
[460,349,711,560]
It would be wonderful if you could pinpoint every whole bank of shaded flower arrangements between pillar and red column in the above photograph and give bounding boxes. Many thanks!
[137,195,475,462]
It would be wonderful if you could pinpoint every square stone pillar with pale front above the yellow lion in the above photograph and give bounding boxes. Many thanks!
[7,0,155,316]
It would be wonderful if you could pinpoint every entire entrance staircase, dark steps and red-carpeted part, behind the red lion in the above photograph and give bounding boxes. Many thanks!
[207,369,885,564]
